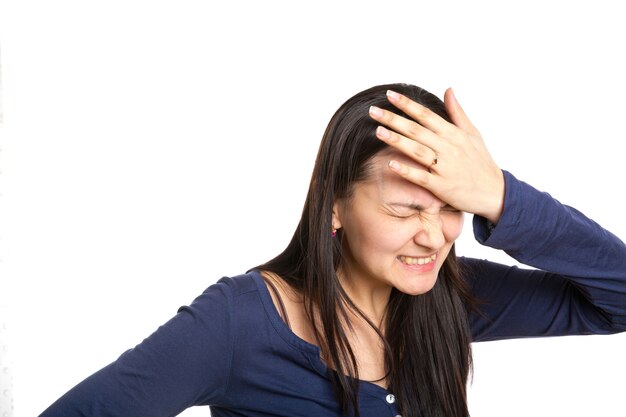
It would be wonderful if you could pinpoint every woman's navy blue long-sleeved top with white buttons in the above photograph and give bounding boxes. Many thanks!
[41,172,626,417]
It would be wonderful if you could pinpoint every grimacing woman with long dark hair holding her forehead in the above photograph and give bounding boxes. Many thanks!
[42,84,626,417]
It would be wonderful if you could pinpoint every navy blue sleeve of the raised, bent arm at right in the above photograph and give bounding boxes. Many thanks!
[461,171,626,341]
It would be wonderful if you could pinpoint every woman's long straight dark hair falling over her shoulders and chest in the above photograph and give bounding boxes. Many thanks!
[257,84,472,417]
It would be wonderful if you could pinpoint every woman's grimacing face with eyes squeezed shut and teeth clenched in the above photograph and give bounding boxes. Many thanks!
[333,150,463,295]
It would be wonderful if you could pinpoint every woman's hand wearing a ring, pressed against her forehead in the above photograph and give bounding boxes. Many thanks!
[370,89,504,224]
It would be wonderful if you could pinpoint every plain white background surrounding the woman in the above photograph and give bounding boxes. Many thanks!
[0,0,626,417]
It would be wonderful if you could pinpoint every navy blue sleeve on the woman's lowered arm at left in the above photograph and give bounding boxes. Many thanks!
[40,280,234,417]
